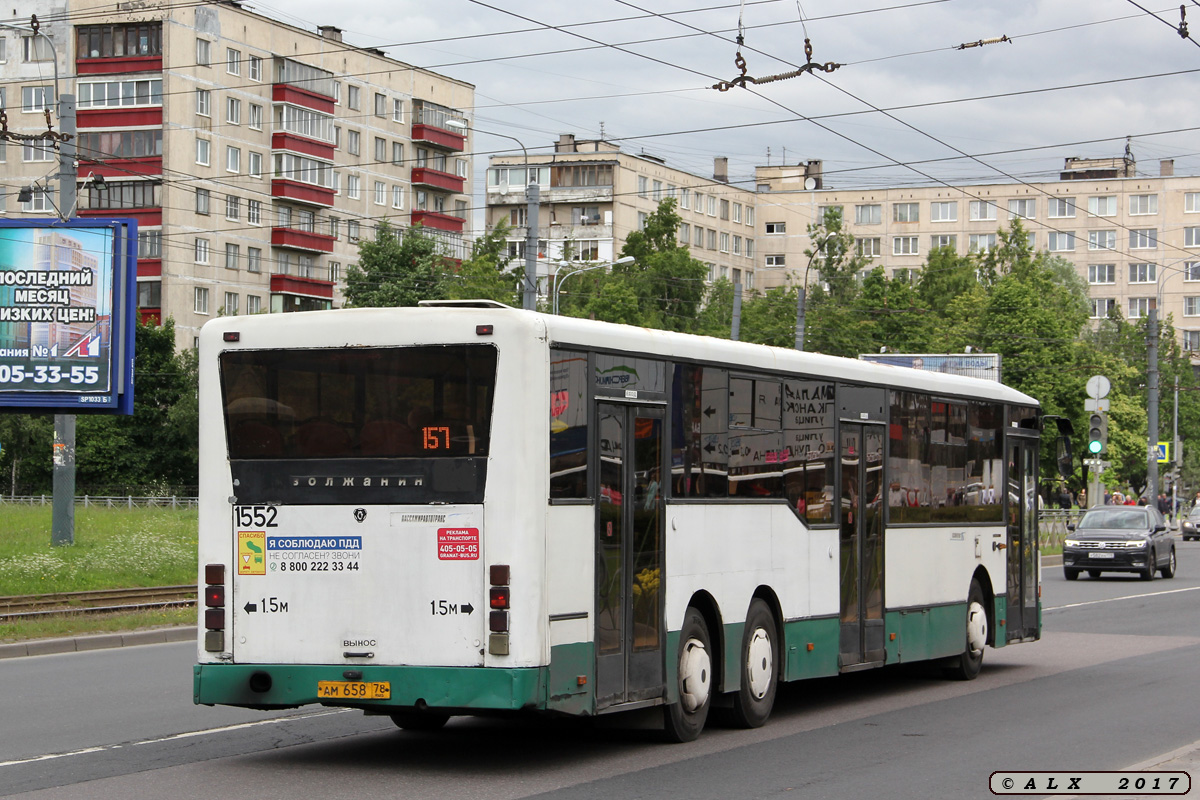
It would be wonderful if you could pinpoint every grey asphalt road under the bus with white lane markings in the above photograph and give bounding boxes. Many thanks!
[0,542,1200,800]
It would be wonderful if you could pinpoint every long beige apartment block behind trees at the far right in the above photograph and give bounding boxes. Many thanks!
[756,152,1200,355]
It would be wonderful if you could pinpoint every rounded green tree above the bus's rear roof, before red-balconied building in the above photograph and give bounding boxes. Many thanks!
[344,219,448,308]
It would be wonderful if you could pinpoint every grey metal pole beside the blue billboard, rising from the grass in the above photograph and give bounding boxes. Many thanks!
[50,95,79,546]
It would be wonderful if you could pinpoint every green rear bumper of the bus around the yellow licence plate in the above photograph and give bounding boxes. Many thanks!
[192,664,545,712]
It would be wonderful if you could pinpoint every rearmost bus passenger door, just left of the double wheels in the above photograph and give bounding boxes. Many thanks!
[595,403,665,710]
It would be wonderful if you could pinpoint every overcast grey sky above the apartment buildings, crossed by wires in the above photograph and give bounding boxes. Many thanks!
[246,0,1200,188]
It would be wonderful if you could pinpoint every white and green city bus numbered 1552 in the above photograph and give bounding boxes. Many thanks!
[194,301,1040,740]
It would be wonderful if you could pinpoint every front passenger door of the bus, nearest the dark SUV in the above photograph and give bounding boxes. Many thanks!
[1004,439,1038,642]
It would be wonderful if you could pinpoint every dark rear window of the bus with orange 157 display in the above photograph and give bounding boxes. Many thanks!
[221,344,496,459]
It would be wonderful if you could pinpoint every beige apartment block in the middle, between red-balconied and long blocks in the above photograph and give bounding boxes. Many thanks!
[487,133,756,295]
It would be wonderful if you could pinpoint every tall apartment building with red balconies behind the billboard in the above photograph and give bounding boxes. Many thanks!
[0,0,474,348]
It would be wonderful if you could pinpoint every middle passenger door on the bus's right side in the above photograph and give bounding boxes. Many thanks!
[838,423,886,672]
